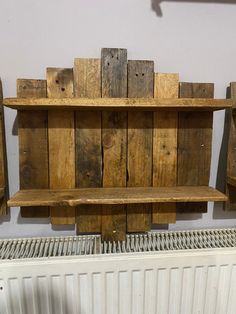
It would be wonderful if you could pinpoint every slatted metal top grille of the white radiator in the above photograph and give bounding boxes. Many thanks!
[0,229,236,260]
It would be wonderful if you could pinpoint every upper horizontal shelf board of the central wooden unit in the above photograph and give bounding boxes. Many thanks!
[3,98,232,111]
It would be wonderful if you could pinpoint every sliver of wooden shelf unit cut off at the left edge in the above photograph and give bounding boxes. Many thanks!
[0,79,9,216]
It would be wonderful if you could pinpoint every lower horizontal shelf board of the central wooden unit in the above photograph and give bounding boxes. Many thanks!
[8,186,228,207]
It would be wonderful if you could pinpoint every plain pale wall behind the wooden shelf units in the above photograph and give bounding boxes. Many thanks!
[0,0,236,238]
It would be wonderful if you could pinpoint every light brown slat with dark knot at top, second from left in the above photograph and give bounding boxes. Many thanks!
[47,68,75,224]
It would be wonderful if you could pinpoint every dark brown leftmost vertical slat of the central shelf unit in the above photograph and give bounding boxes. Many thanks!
[17,79,49,217]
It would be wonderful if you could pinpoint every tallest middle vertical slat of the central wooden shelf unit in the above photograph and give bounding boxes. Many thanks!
[101,48,127,240]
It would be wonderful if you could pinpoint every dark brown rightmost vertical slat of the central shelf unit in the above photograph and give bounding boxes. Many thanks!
[178,83,214,213]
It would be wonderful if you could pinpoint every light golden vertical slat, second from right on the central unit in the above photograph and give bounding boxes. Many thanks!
[152,73,179,224]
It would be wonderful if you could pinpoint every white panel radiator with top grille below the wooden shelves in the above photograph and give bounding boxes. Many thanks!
[0,229,236,314]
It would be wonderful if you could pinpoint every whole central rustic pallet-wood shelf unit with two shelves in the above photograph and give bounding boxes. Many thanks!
[4,48,232,241]
